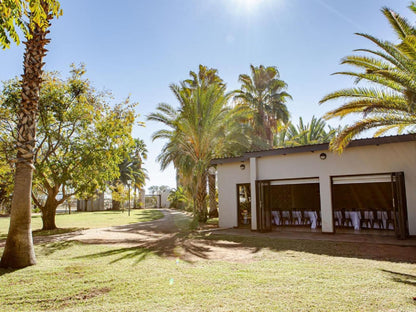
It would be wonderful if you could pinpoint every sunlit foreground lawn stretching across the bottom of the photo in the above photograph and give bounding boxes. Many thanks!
[0,235,416,312]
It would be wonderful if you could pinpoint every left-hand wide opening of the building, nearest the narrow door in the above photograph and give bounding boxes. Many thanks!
[257,178,321,232]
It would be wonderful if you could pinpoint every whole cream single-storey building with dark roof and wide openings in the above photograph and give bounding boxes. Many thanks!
[212,134,416,239]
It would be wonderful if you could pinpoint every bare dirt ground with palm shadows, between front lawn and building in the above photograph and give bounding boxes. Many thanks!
[0,209,416,263]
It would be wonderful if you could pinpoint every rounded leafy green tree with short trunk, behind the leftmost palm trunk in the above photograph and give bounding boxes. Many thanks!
[0,67,135,230]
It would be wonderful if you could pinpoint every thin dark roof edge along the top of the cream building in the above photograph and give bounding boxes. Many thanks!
[211,133,416,165]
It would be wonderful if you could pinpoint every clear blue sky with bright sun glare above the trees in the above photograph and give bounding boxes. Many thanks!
[0,0,414,187]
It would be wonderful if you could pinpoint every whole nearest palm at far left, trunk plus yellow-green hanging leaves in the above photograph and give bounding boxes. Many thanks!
[0,0,62,268]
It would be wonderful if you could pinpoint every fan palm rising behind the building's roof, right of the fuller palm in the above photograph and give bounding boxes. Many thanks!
[235,65,291,147]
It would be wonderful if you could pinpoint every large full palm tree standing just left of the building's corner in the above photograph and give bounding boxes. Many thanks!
[148,70,247,221]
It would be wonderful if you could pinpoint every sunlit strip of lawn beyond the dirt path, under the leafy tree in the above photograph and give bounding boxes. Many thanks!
[0,209,163,239]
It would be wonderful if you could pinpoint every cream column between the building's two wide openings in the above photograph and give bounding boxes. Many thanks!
[319,176,334,233]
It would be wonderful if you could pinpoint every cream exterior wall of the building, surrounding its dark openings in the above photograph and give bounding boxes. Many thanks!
[217,141,416,235]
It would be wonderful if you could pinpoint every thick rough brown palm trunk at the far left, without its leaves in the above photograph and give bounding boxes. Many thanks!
[0,9,51,268]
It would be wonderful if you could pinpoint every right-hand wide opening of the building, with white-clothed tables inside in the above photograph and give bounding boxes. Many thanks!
[332,172,408,239]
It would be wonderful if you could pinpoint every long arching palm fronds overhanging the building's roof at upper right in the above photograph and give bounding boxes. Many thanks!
[320,3,416,152]
